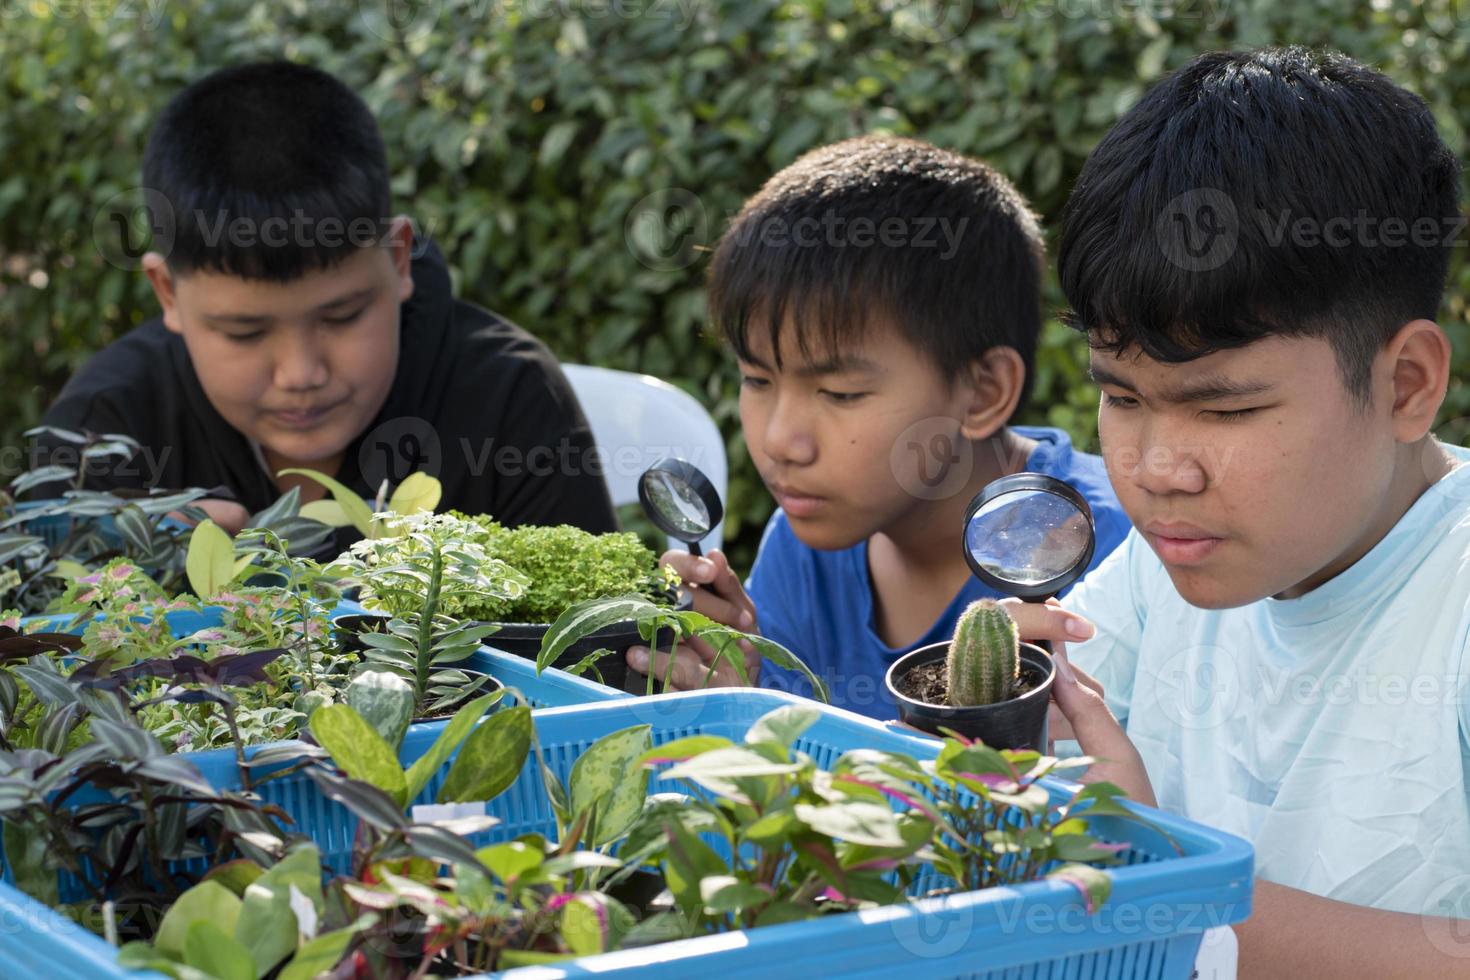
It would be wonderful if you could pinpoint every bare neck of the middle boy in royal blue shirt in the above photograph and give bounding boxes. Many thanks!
[867,429,1036,648]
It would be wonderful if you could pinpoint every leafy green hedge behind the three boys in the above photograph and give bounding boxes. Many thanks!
[0,0,1470,564]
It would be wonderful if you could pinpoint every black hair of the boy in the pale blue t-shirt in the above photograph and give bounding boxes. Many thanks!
[1057,47,1463,406]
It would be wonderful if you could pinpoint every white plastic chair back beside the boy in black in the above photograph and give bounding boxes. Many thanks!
[562,364,729,552]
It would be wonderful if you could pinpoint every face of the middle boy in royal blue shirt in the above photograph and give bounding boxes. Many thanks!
[739,325,993,550]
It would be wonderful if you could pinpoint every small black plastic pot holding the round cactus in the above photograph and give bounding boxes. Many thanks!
[883,641,1057,752]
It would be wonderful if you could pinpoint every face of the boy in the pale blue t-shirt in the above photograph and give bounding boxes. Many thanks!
[1092,338,1398,608]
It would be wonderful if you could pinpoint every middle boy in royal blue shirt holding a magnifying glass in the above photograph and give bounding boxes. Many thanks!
[629,137,1127,718]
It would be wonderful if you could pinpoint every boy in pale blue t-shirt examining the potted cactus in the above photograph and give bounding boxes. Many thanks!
[1013,48,1470,977]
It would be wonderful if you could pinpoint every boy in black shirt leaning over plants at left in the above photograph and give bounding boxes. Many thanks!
[41,63,616,532]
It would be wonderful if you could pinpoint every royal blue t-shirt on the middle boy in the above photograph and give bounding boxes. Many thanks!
[745,426,1130,720]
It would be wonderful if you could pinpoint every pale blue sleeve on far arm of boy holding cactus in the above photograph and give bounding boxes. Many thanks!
[1063,532,1152,726]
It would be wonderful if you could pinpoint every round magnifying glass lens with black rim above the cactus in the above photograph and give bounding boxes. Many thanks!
[964,473,1097,646]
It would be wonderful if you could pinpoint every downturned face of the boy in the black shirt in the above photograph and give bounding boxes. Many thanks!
[146,230,413,470]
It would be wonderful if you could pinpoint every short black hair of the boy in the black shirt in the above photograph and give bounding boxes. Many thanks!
[143,62,390,282]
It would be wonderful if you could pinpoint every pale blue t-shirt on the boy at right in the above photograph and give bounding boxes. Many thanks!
[1064,447,1470,917]
